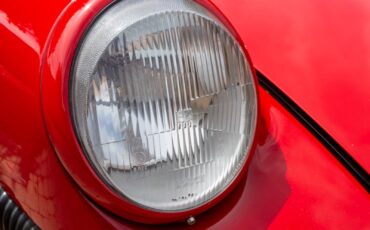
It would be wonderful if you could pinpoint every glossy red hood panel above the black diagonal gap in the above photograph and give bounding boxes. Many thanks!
[213,0,370,172]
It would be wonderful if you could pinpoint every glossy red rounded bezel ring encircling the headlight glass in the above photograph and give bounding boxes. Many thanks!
[42,1,258,223]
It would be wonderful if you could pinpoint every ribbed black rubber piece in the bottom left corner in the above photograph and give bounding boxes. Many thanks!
[0,187,40,230]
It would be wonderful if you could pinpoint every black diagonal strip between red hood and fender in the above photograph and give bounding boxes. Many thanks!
[256,70,370,193]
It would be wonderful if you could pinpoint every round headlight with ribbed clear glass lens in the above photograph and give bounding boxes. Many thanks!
[70,0,257,211]
